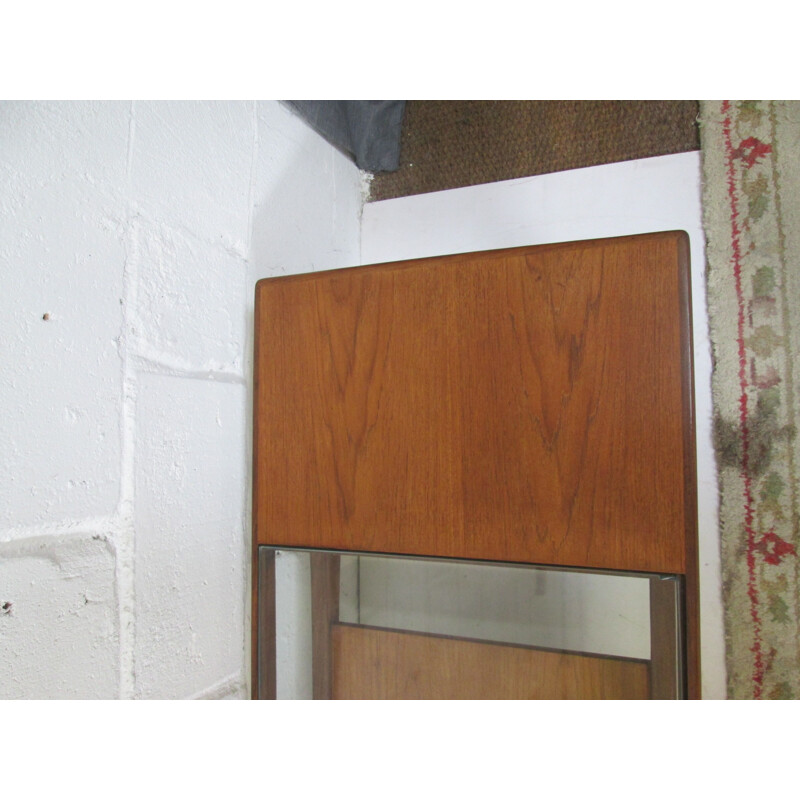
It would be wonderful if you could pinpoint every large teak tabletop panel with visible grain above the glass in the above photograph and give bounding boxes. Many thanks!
[254,232,694,573]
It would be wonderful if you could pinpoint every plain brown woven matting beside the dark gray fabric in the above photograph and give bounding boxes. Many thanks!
[370,100,700,200]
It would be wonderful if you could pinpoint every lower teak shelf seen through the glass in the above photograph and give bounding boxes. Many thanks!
[331,625,650,700]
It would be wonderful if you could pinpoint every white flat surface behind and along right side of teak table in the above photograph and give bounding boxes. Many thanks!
[361,152,726,698]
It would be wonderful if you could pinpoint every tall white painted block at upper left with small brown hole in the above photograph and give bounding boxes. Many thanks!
[0,103,127,530]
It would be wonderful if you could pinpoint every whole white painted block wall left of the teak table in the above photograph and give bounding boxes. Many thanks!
[0,102,361,698]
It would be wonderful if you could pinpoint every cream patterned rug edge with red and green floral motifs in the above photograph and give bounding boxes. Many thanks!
[701,101,800,699]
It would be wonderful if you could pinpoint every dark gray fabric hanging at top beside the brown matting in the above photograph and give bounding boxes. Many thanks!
[284,100,406,172]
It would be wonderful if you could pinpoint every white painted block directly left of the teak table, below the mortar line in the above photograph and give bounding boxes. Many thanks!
[135,374,247,699]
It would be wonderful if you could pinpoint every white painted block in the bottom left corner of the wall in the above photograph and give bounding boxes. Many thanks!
[0,534,119,700]
